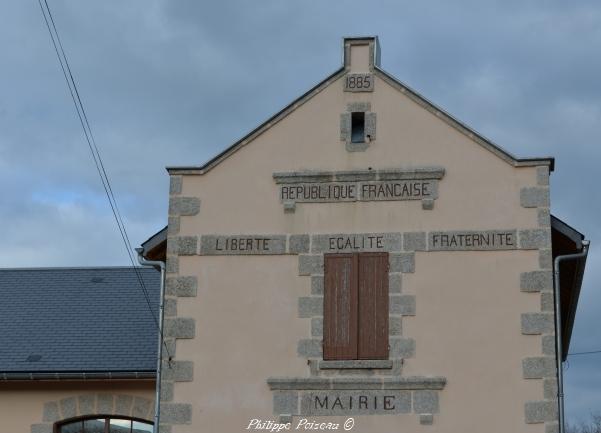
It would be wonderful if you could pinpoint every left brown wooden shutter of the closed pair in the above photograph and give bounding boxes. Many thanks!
[323,254,358,360]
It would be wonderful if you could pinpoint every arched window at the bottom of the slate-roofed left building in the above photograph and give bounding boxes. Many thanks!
[54,416,152,433]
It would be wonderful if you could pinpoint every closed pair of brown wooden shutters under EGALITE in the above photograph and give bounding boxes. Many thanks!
[323,253,388,360]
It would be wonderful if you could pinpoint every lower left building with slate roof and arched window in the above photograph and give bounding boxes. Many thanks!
[0,267,160,433]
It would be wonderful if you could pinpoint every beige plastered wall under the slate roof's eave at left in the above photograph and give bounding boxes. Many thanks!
[0,380,155,433]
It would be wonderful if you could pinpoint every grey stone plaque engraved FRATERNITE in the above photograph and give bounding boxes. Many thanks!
[428,230,517,251]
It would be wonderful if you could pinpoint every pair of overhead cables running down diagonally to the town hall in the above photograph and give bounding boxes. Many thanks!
[38,0,171,358]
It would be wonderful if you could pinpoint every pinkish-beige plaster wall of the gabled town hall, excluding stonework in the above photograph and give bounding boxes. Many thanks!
[166,64,544,433]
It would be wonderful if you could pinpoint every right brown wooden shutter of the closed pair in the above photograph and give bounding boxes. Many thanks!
[357,253,388,359]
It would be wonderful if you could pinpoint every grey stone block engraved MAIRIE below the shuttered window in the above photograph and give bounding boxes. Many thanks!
[301,390,411,416]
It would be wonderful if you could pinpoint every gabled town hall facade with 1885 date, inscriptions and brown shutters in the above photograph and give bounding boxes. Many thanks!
[149,37,584,433]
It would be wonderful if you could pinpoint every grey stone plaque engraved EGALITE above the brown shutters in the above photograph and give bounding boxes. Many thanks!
[311,233,401,253]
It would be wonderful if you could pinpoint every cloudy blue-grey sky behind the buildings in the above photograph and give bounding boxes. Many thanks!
[0,0,601,420]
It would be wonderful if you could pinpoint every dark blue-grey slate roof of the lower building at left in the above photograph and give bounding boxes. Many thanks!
[0,267,160,373]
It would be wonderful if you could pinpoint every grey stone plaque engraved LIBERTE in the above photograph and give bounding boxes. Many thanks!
[200,235,286,256]
